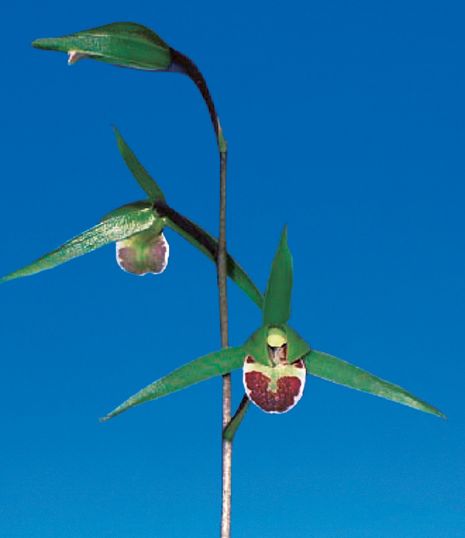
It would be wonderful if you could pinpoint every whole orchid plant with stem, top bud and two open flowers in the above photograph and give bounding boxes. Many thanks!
[0,23,444,538]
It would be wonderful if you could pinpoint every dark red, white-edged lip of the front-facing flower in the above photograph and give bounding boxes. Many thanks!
[243,355,307,413]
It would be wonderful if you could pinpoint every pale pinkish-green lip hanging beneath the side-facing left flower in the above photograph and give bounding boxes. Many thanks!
[116,230,170,276]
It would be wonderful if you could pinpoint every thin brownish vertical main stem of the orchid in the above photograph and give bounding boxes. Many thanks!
[217,146,232,538]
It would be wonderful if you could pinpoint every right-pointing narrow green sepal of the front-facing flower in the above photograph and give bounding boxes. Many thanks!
[305,350,446,418]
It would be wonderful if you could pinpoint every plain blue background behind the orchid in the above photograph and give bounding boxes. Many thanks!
[0,0,465,538]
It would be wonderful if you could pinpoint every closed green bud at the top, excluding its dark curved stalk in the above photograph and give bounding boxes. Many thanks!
[32,22,171,71]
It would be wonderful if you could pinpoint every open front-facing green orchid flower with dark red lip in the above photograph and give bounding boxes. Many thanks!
[102,228,444,430]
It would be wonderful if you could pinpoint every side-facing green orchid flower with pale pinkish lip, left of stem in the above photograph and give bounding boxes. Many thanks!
[0,129,263,307]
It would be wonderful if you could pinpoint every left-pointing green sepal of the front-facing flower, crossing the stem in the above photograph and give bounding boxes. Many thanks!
[101,347,245,421]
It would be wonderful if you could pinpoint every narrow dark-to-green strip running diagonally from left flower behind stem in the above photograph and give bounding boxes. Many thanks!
[155,203,263,308]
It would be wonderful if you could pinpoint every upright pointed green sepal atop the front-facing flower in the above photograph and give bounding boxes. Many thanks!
[263,226,292,325]
